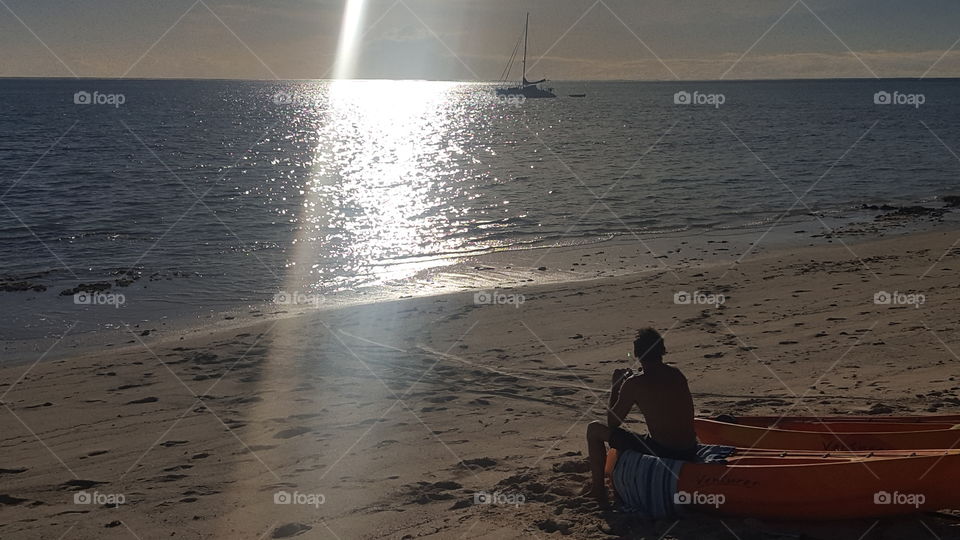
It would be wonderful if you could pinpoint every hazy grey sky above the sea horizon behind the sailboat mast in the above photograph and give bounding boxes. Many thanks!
[0,0,960,80]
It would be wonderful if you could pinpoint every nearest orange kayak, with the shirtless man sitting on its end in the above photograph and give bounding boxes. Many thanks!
[607,450,960,520]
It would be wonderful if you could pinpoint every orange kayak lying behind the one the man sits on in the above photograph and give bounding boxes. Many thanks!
[694,417,960,452]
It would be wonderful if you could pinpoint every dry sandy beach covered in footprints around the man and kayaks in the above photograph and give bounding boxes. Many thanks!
[0,226,960,539]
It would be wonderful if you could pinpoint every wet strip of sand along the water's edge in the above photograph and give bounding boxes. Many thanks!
[3,208,960,365]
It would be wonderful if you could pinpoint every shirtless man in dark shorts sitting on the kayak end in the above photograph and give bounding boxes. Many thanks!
[587,328,697,501]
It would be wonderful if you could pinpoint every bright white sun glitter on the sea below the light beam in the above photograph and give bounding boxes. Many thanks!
[291,80,468,296]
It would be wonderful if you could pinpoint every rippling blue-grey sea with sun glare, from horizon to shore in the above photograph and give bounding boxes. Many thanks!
[0,79,960,339]
